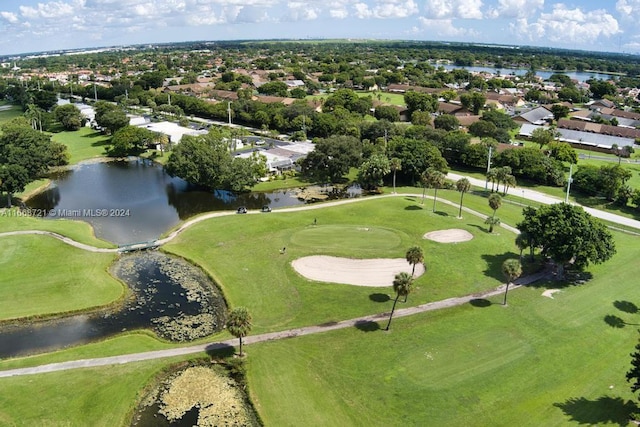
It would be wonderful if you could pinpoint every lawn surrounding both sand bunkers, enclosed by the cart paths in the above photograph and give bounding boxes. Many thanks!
[164,197,517,333]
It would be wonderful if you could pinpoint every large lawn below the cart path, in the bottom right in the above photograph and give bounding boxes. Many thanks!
[247,231,639,426]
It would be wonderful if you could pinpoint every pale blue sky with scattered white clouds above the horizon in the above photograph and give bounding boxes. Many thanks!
[0,0,640,55]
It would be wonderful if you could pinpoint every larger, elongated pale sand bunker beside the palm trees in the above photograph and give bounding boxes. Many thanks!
[291,255,424,287]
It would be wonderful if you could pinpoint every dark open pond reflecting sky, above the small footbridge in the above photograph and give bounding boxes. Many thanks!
[26,159,312,245]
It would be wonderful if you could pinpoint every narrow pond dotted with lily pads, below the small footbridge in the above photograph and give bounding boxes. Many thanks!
[0,251,227,358]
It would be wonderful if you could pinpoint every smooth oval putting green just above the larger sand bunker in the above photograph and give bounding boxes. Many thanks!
[291,225,402,251]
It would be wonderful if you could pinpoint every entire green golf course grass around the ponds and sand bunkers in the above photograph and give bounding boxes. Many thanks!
[0,188,640,426]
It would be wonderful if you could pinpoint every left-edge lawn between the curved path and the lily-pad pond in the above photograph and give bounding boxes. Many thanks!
[0,235,124,320]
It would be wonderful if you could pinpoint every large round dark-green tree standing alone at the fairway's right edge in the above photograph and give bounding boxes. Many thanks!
[517,203,616,270]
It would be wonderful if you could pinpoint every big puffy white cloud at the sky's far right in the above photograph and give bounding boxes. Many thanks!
[511,4,621,45]
